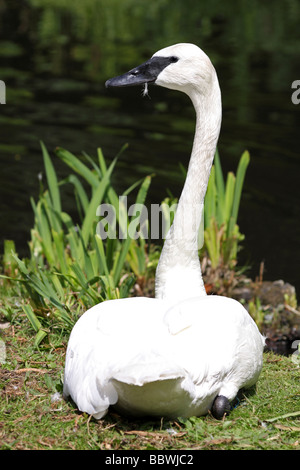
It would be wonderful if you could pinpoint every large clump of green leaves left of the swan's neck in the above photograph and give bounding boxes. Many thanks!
[2,144,156,334]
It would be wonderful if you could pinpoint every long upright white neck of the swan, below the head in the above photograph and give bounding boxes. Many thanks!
[155,73,222,302]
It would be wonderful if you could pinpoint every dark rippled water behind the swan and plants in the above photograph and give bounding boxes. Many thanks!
[0,0,300,292]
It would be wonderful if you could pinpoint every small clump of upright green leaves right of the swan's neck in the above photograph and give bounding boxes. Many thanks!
[204,151,250,269]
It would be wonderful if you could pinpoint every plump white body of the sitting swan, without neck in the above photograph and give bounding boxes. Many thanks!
[64,296,262,418]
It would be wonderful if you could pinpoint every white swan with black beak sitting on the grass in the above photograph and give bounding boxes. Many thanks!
[64,44,264,419]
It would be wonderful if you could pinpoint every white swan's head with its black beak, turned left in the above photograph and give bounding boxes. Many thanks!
[105,43,216,95]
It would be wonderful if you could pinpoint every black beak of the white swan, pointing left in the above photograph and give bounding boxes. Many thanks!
[105,56,178,88]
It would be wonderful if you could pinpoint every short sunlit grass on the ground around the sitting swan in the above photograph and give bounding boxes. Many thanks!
[0,314,300,450]
